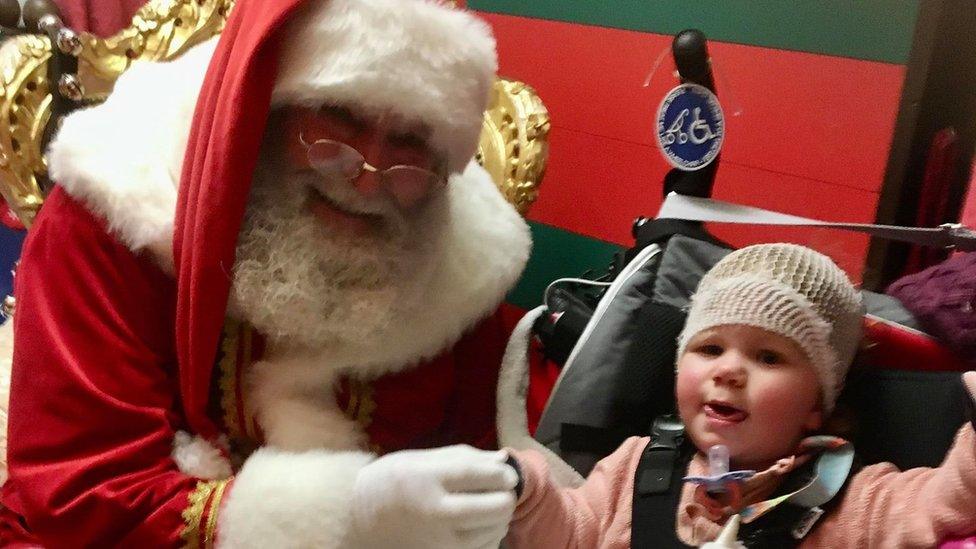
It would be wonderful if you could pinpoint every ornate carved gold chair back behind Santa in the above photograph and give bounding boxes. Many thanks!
[0,0,549,484]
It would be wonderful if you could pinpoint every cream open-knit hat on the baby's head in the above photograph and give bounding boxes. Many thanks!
[678,244,864,414]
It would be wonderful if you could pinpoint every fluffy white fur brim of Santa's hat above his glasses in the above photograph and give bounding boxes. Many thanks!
[272,0,497,173]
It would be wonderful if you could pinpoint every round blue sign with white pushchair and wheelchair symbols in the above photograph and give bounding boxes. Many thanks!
[656,84,725,171]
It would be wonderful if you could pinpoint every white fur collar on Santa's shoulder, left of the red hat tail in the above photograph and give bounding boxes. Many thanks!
[47,38,217,267]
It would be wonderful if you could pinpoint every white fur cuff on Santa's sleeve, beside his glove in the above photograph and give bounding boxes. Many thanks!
[218,448,373,549]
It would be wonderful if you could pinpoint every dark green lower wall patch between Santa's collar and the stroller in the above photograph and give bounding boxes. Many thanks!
[508,221,622,309]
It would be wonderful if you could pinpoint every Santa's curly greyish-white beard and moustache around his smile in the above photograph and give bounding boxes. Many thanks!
[231,159,445,351]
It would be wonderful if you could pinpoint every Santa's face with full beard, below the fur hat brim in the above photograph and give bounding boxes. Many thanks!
[231,103,447,348]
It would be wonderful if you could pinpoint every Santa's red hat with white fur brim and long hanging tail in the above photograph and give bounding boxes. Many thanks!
[173,0,496,437]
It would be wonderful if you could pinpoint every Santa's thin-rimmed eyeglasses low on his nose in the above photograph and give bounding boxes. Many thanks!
[298,134,447,208]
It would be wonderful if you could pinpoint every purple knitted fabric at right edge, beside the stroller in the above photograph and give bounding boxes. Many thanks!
[887,252,976,362]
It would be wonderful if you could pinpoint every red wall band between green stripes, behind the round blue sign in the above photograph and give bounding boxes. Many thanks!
[467,0,912,298]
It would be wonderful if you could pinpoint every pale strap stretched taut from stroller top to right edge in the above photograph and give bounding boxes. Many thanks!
[657,193,976,252]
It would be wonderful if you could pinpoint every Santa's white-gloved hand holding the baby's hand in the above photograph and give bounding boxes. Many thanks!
[348,446,518,549]
